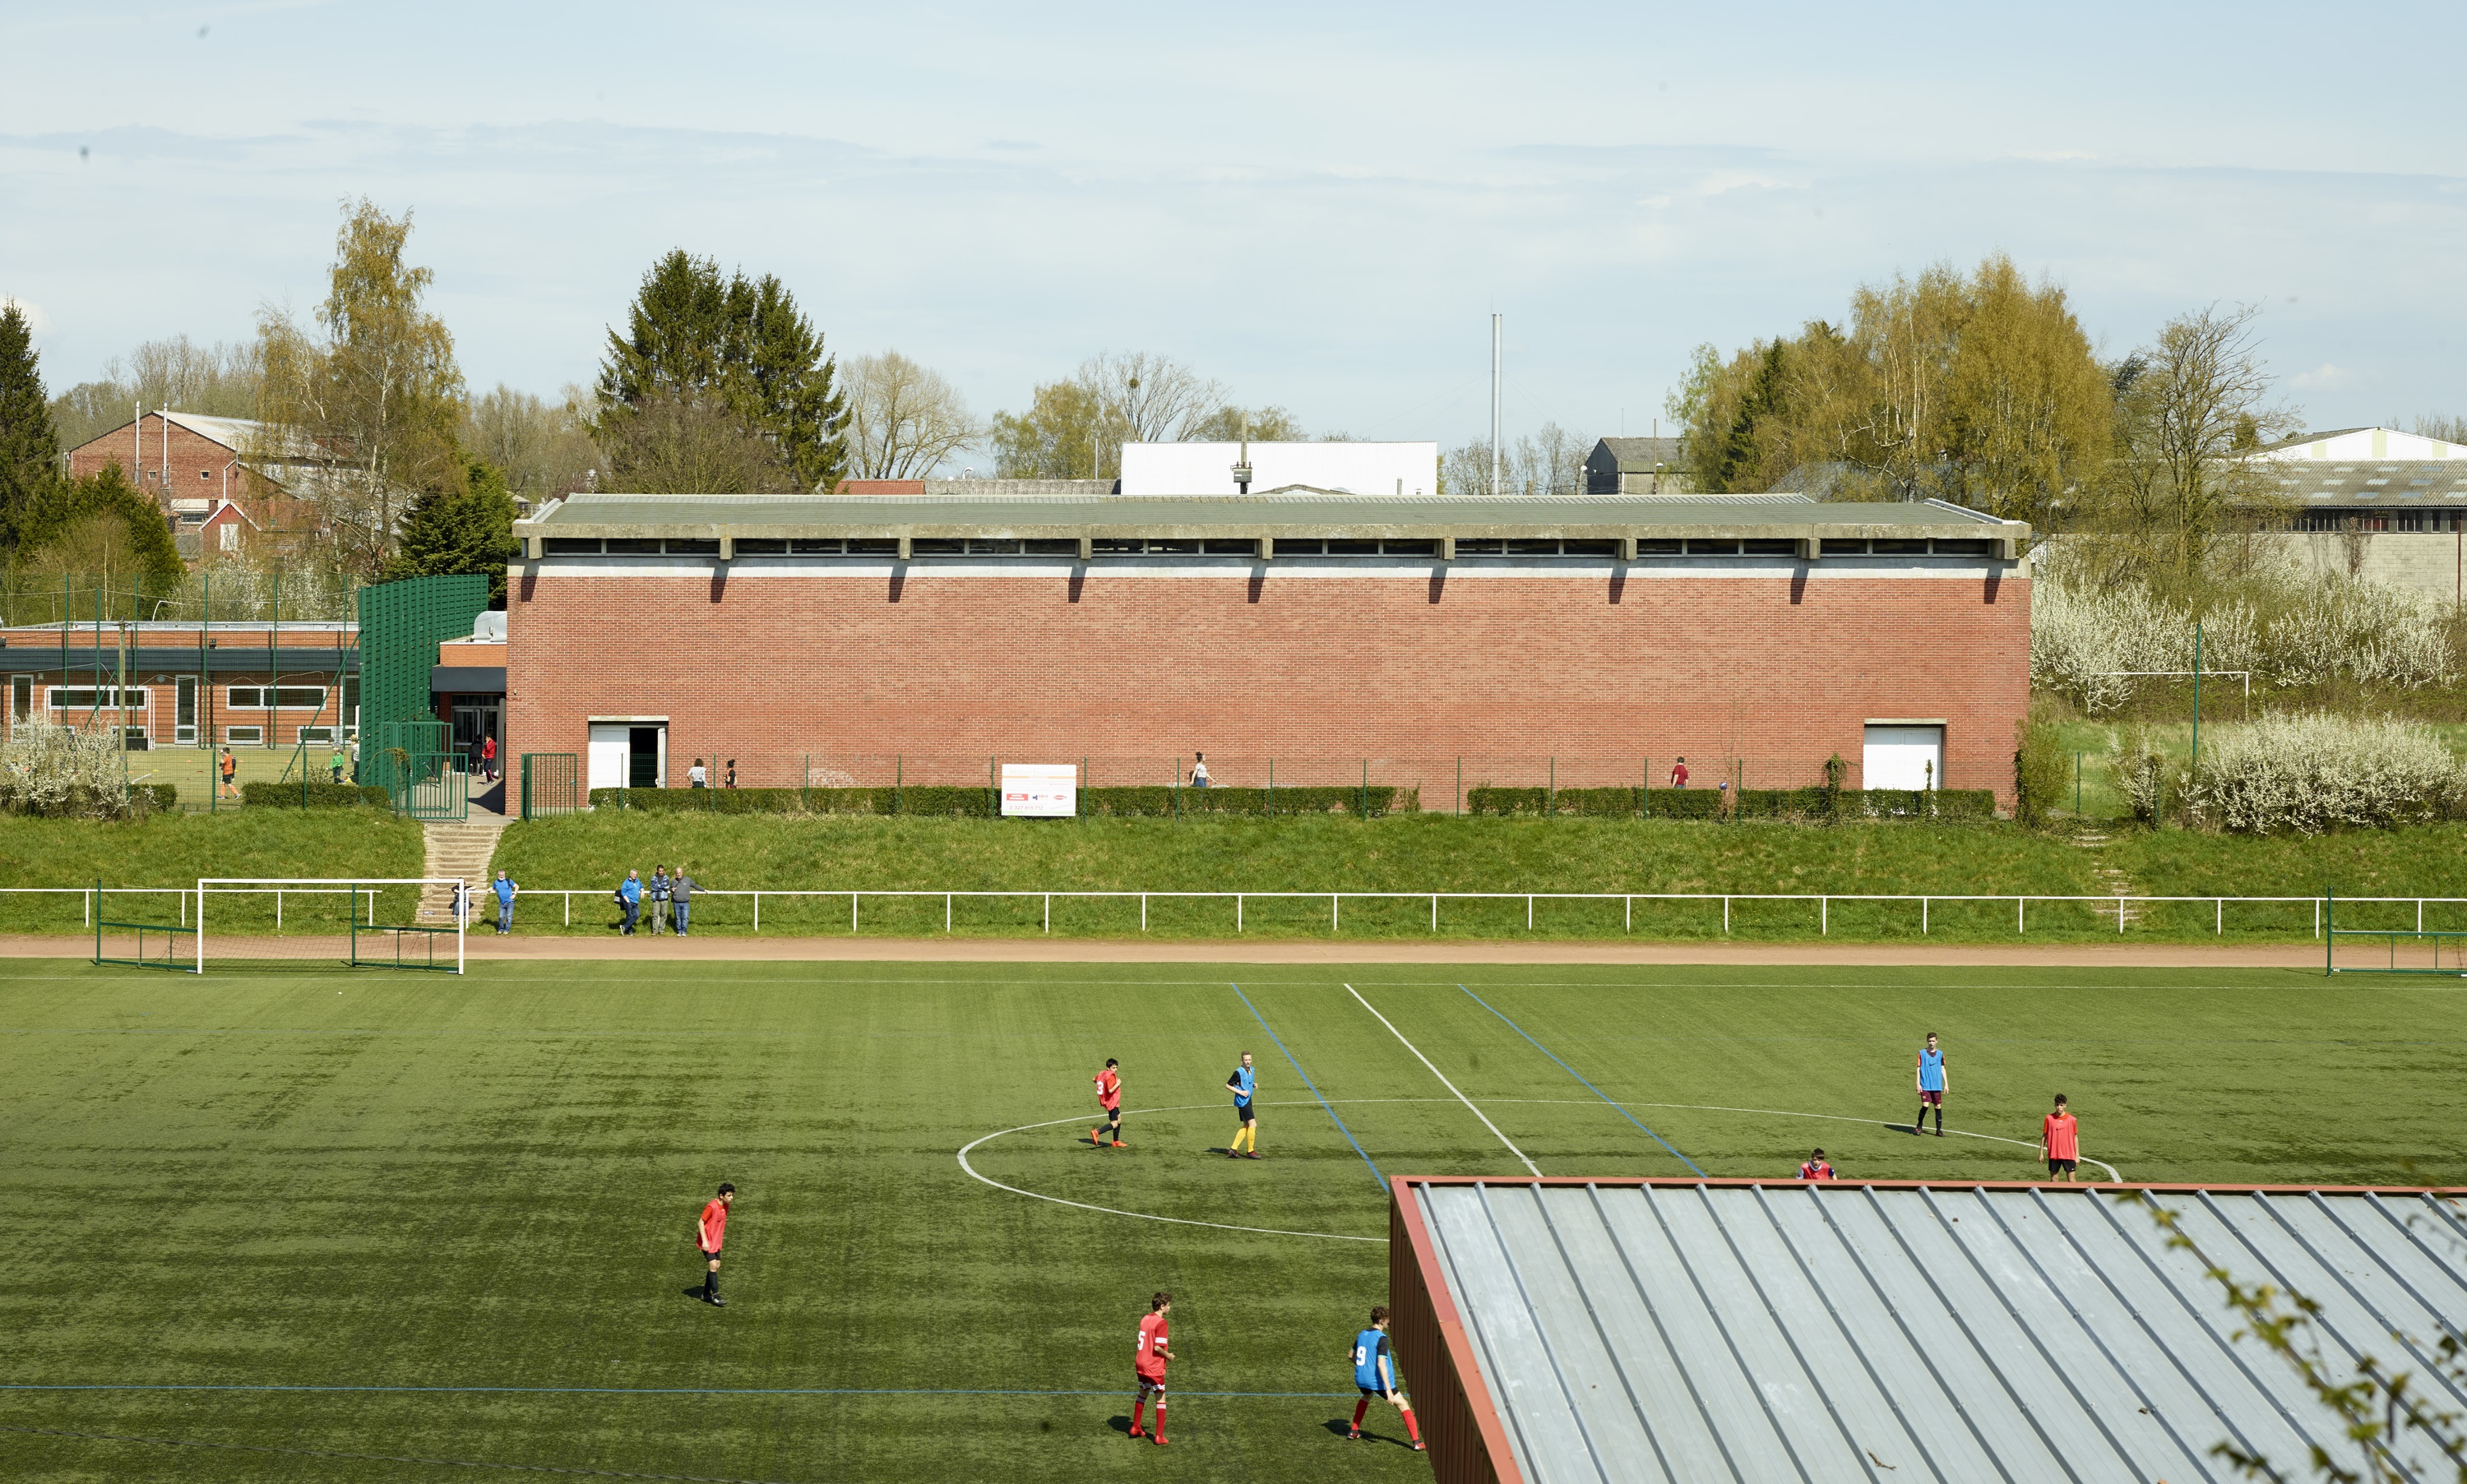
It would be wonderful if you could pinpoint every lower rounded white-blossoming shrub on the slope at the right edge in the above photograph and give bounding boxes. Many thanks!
[2171,715,2467,835]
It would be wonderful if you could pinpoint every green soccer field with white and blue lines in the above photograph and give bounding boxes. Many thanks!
[0,961,2467,1484]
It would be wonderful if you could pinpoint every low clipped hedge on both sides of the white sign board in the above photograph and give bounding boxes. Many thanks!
[592,784,1421,818]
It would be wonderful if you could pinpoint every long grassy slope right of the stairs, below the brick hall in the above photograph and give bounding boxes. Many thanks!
[481,811,2467,941]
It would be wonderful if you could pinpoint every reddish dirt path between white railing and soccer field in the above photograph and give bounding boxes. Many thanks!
[14,929,2321,973]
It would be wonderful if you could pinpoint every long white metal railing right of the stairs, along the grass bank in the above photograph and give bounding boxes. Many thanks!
[471,887,2467,936]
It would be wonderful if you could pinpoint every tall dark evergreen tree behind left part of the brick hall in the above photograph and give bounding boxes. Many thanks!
[595,249,849,491]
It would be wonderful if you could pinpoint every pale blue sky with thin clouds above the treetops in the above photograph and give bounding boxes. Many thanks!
[0,2,2467,444]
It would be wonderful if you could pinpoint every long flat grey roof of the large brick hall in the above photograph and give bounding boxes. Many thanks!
[513,493,2030,540]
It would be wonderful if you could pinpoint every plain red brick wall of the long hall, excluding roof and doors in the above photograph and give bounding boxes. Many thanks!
[506,565,2030,808]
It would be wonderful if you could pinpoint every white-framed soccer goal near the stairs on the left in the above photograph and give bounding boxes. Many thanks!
[195,875,471,973]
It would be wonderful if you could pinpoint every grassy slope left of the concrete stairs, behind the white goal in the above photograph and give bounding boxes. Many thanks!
[0,808,422,932]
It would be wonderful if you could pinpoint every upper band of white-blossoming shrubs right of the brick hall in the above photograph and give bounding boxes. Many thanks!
[2030,562,2460,715]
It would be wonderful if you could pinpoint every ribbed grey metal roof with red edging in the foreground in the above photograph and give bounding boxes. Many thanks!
[1399,1181,2467,1484]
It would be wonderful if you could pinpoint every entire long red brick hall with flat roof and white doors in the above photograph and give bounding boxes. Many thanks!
[506,486,2030,808]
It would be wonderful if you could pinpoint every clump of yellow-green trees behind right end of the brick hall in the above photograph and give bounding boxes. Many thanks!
[1668,254,2349,577]
